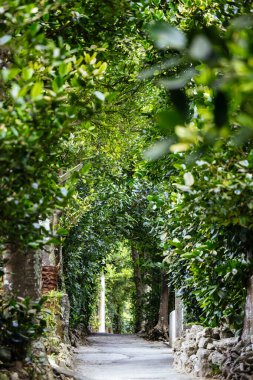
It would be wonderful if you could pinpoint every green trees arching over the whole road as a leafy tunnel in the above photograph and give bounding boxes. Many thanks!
[0,0,253,378]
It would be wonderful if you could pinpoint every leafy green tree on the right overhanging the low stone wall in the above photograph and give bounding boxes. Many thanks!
[141,4,252,336]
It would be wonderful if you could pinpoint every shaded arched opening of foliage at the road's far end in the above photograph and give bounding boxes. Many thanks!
[63,214,174,338]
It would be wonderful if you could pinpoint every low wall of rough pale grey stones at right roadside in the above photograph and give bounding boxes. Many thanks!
[173,325,253,380]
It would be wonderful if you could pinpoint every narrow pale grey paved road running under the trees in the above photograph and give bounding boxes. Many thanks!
[76,334,191,380]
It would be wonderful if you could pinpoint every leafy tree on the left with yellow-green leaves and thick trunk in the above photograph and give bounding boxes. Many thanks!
[0,1,106,297]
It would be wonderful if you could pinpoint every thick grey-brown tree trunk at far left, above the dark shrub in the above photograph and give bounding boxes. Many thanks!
[4,244,42,300]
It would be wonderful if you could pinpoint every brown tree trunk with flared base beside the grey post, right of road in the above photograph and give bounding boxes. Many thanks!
[149,272,169,340]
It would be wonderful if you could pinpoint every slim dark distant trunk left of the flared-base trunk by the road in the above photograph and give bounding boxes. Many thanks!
[131,248,144,333]
